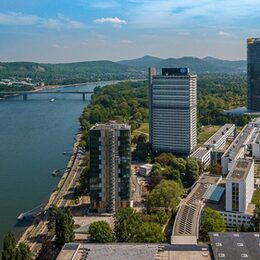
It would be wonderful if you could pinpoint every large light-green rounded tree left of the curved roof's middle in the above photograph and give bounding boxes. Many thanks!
[146,180,182,211]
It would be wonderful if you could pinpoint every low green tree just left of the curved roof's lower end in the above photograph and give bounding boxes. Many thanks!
[135,222,165,243]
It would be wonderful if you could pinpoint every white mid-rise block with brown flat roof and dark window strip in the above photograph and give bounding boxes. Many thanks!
[226,159,254,213]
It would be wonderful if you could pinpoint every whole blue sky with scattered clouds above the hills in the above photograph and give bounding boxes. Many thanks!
[0,0,260,63]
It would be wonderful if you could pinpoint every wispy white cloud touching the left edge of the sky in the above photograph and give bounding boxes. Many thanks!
[0,12,40,25]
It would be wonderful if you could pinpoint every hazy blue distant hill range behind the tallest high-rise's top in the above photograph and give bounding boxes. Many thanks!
[118,56,246,74]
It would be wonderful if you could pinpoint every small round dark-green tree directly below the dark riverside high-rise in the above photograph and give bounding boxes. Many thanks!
[89,221,113,243]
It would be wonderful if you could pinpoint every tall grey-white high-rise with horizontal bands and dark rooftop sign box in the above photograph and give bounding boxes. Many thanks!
[149,68,197,155]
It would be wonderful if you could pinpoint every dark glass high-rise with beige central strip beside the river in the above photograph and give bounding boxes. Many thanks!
[89,123,131,213]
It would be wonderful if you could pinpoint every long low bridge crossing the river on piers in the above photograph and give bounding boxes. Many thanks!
[0,90,94,101]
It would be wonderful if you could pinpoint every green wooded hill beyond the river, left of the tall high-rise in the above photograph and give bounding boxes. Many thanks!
[0,61,141,84]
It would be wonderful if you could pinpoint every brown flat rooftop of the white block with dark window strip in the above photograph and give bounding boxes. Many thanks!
[227,159,253,180]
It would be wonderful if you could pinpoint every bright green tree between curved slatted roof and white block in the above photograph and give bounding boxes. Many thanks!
[200,208,226,241]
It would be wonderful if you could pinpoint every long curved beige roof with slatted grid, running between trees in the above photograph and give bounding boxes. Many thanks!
[171,174,221,245]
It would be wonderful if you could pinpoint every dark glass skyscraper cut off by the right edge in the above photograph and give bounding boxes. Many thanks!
[247,38,260,111]
